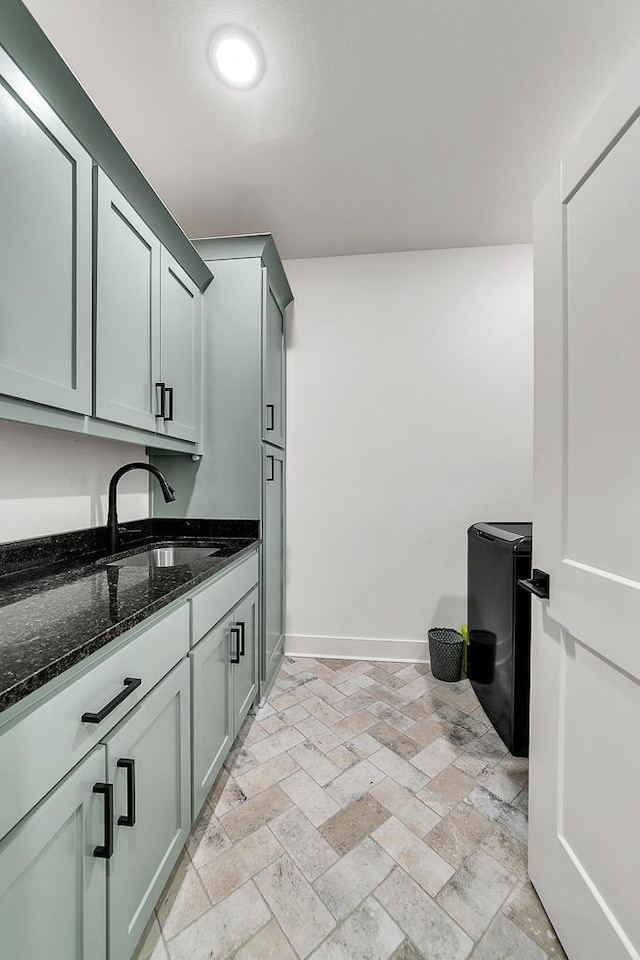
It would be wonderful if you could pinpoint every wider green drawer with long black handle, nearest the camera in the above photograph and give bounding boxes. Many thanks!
[0,603,189,837]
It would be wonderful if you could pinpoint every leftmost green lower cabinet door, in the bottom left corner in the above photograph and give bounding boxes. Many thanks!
[0,746,107,960]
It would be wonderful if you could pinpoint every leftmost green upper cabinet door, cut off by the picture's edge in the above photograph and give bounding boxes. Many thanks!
[0,50,92,413]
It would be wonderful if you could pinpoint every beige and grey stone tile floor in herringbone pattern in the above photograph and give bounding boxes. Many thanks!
[137,658,565,960]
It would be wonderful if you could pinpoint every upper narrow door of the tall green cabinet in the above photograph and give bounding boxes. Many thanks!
[262,268,285,447]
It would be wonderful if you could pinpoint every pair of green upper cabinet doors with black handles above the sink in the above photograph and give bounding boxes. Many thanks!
[95,170,202,442]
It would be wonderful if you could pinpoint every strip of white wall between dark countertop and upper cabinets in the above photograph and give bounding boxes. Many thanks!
[0,420,149,543]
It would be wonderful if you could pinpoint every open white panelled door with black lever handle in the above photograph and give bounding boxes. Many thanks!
[529,58,640,960]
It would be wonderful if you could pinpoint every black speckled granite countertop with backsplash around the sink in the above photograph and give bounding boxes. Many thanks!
[0,519,260,711]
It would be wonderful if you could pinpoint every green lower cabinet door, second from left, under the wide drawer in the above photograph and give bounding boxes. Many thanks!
[106,658,191,960]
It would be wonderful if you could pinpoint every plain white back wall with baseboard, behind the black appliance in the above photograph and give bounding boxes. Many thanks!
[285,245,533,657]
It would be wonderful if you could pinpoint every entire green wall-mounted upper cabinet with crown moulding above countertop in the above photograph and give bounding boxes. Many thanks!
[0,9,212,453]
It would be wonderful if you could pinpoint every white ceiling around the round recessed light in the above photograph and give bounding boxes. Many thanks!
[22,0,640,258]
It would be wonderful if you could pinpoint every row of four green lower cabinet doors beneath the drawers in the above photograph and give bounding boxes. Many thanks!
[0,585,261,960]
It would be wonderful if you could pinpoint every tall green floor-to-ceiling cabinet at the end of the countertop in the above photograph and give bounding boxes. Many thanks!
[154,234,293,696]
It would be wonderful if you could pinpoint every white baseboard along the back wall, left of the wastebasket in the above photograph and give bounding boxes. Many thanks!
[284,634,429,663]
